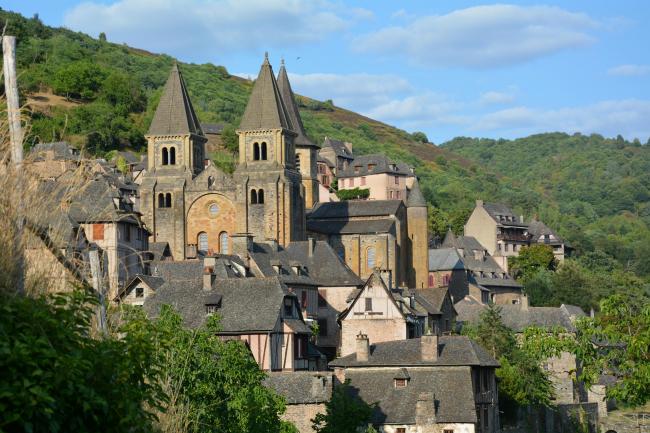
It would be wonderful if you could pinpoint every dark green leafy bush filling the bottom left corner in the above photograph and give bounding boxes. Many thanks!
[0,291,167,432]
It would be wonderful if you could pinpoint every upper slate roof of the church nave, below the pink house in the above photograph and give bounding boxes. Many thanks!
[308,200,403,220]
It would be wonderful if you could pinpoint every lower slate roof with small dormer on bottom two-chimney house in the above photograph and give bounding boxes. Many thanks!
[345,367,476,425]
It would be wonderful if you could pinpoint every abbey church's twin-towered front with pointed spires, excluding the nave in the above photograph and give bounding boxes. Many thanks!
[140,54,308,259]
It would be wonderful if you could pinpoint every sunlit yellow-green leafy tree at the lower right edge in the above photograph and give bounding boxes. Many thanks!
[577,294,650,406]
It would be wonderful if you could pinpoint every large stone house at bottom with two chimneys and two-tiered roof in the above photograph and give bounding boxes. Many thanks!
[330,334,500,433]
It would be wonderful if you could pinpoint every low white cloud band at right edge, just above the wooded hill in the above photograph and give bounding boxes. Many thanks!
[471,99,650,140]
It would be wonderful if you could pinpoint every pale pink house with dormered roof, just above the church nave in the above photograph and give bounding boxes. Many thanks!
[337,154,415,200]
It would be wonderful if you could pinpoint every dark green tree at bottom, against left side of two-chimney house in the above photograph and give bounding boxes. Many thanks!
[311,380,375,433]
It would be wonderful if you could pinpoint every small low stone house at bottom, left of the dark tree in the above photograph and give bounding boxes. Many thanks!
[264,371,334,433]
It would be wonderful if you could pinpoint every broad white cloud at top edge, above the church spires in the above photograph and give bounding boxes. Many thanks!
[64,0,350,58]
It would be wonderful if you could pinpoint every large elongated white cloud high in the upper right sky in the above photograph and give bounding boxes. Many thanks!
[354,5,598,68]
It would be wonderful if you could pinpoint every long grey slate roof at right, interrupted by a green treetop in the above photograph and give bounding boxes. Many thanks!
[454,299,585,332]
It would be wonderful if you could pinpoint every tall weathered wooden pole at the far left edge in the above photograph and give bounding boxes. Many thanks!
[2,31,25,294]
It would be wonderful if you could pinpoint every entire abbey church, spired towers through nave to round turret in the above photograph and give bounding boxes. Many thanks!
[140,57,428,287]
